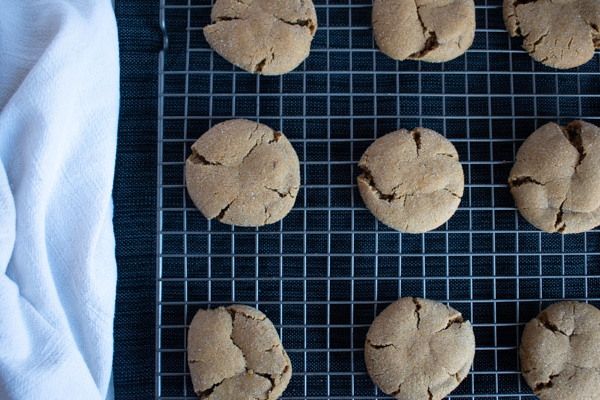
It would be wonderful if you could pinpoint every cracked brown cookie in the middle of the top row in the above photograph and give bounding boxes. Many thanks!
[372,0,475,62]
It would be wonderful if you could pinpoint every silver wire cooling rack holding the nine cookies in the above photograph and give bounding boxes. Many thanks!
[156,0,600,400]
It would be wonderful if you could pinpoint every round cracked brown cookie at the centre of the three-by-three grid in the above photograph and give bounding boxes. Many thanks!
[358,128,464,233]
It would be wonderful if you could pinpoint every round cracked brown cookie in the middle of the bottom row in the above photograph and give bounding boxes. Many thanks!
[365,297,475,400]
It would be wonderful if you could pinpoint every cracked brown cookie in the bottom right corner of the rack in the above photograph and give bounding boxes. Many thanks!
[521,301,600,400]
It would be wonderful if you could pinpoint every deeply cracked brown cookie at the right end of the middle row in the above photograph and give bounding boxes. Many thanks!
[508,121,600,233]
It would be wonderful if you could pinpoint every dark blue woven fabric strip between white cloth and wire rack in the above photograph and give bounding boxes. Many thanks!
[113,0,162,400]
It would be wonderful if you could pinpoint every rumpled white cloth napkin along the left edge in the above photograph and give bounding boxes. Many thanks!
[0,0,119,400]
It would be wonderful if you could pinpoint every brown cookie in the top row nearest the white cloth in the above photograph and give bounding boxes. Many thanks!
[204,0,317,75]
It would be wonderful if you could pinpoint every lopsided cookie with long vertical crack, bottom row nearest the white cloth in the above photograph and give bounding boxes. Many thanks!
[188,305,292,400]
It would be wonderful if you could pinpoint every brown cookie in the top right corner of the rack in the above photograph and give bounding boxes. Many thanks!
[503,0,600,68]
